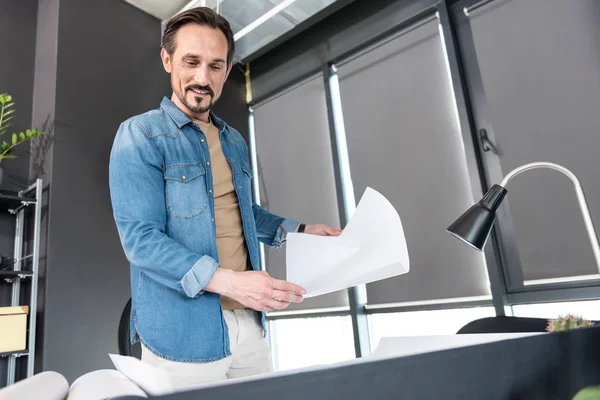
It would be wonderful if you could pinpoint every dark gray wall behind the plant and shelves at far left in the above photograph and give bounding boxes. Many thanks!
[0,0,37,386]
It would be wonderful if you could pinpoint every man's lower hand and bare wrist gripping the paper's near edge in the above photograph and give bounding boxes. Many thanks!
[205,268,306,311]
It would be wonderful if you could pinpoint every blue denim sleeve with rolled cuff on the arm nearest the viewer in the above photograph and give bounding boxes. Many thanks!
[109,120,219,298]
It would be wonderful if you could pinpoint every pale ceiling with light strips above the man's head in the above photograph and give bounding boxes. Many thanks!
[125,0,338,62]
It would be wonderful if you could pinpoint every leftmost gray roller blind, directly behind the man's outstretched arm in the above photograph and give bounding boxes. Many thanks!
[254,75,348,311]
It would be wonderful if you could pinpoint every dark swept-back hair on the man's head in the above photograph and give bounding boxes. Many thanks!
[162,7,235,64]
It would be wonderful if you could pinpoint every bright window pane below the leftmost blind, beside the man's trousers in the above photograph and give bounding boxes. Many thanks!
[270,316,355,371]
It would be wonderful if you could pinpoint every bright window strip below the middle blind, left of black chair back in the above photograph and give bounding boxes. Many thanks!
[369,307,495,350]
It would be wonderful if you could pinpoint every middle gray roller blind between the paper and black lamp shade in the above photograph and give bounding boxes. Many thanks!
[338,18,490,305]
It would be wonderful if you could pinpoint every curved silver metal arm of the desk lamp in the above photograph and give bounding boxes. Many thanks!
[500,162,600,272]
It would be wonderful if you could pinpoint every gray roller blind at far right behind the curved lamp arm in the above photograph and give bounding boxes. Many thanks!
[470,0,600,280]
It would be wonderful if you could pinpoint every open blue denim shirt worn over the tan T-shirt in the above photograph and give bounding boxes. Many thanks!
[109,98,298,363]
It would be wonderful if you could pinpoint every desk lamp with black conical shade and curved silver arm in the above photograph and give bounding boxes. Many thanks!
[447,162,600,271]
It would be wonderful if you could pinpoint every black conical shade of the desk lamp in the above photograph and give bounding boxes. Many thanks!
[448,185,506,251]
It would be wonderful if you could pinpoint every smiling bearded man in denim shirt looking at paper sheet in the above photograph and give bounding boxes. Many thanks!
[110,8,341,388]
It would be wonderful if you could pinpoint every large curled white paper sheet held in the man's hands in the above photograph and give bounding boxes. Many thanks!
[286,188,410,297]
